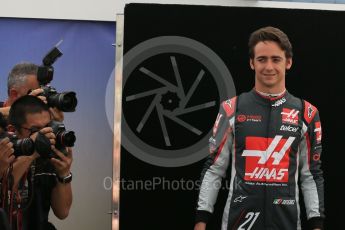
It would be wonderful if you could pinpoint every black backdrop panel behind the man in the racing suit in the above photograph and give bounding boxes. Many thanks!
[120,4,345,230]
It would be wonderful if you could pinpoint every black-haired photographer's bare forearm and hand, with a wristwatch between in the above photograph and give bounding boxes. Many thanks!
[50,147,73,219]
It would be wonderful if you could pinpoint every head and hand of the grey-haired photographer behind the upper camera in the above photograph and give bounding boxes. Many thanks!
[0,62,64,121]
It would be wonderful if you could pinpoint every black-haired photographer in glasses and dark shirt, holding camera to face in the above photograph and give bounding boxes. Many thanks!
[6,95,75,230]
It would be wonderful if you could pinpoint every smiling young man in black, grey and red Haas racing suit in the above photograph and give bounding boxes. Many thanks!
[195,27,324,230]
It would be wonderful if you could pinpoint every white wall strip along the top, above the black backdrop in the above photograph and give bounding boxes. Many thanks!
[0,0,345,21]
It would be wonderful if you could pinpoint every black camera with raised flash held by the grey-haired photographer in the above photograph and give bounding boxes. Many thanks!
[37,43,78,112]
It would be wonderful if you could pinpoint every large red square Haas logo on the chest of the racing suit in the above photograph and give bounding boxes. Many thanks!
[242,135,295,182]
